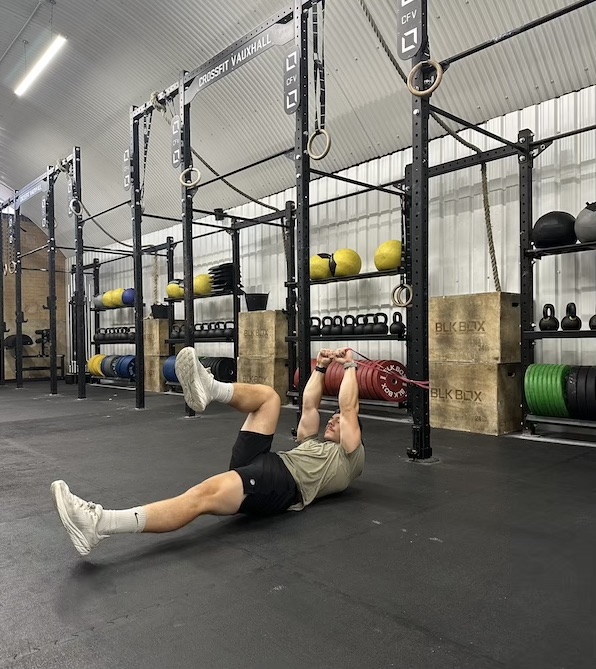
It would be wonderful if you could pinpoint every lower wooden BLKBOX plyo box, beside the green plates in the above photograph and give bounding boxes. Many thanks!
[430,362,522,435]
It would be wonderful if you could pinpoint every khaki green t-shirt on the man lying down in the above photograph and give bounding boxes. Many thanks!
[277,436,364,511]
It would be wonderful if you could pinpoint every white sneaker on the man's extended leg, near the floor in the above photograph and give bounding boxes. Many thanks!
[51,481,108,555]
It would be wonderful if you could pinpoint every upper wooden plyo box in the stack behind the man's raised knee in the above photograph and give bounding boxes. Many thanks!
[238,311,288,359]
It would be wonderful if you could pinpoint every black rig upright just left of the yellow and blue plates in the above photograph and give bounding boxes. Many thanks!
[70,146,87,400]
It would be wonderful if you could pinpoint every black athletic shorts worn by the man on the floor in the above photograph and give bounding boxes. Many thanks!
[230,430,300,515]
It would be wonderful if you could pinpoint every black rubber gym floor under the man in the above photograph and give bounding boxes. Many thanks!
[0,383,596,669]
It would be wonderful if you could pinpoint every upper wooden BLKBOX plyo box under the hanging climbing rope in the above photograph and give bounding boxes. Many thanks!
[428,293,521,363]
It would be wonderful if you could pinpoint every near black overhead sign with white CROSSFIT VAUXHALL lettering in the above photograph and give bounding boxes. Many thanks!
[186,23,293,102]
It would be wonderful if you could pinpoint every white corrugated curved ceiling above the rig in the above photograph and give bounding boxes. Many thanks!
[0,0,596,246]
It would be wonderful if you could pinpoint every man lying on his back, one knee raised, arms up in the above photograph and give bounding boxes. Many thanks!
[51,347,364,555]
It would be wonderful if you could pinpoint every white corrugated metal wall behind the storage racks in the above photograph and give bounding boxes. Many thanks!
[79,87,596,364]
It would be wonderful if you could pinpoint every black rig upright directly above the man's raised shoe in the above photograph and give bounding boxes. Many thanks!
[178,72,195,416]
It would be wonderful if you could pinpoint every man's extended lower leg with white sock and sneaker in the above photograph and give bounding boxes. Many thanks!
[51,471,246,555]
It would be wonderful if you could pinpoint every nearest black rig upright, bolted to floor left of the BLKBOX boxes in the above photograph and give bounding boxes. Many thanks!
[407,0,432,460]
